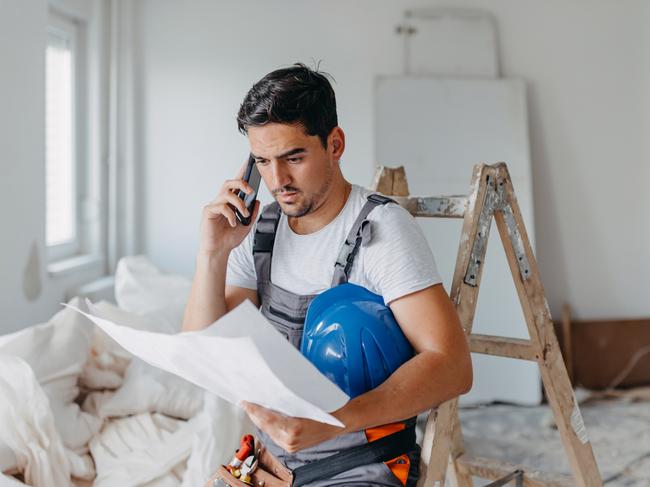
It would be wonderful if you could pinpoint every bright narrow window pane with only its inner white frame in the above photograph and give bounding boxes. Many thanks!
[45,4,101,273]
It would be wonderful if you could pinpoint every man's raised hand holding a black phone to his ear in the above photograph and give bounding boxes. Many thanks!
[200,157,260,253]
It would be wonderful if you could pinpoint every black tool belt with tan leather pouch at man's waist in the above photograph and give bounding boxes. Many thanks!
[213,426,415,487]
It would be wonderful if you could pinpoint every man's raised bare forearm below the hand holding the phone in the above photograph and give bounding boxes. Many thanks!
[182,251,229,331]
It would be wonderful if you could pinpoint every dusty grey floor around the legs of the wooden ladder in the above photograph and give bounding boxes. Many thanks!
[440,388,650,487]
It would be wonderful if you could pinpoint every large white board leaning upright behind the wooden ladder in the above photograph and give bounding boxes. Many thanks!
[375,77,541,404]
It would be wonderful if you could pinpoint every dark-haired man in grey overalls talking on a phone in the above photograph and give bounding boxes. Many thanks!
[183,64,472,486]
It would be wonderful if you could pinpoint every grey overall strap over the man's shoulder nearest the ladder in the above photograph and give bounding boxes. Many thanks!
[332,193,395,287]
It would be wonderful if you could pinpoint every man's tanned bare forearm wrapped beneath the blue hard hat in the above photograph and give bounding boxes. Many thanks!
[334,351,472,431]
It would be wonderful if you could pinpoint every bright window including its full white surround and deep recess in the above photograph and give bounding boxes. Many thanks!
[43,0,116,282]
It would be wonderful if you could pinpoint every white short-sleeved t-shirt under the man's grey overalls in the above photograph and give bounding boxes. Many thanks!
[226,185,442,304]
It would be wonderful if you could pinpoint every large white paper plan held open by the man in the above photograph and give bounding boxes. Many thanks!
[70,300,349,426]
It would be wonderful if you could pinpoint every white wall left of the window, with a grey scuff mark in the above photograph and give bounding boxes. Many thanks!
[0,0,103,334]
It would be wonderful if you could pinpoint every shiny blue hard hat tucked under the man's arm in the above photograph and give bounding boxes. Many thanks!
[300,283,414,398]
